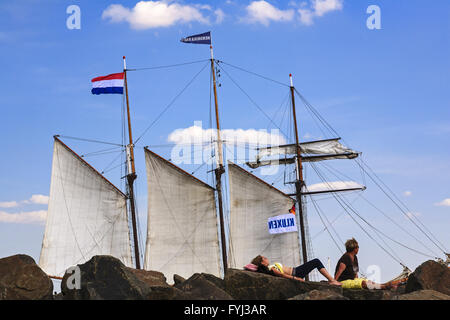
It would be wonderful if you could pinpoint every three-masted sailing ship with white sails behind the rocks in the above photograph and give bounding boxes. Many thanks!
[39,33,448,281]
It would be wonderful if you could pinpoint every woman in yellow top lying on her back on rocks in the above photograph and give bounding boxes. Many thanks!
[246,255,341,286]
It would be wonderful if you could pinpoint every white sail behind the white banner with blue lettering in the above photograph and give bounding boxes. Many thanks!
[228,163,300,269]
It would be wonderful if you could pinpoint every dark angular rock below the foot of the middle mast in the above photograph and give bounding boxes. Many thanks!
[175,273,233,300]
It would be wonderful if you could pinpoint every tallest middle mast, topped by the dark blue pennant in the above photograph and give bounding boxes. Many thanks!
[210,45,228,273]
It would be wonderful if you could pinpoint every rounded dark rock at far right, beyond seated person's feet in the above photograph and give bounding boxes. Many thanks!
[405,260,450,295]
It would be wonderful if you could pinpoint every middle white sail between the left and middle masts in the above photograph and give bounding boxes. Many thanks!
[144,149,221,281]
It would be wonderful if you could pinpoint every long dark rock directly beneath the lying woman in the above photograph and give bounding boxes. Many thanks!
[224,269,342,300]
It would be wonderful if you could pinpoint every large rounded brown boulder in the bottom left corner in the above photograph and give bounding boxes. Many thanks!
[0,255,53,300]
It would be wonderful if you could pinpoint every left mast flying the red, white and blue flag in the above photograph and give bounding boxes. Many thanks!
[123,56,141,269]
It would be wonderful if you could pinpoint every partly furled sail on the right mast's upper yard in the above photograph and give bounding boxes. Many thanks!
[256,138,358,162]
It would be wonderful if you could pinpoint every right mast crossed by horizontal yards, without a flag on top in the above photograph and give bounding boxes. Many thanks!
[289,74,308,280]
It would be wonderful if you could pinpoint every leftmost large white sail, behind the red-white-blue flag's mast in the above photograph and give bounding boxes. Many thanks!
[39,138,133,277]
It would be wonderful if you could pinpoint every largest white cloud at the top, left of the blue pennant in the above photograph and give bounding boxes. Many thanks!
[102,1,213,30]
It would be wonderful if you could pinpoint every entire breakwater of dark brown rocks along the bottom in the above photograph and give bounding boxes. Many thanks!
[0,255,450,300]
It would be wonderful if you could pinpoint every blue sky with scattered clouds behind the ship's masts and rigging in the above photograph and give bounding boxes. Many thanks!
[0,0,450,280]
